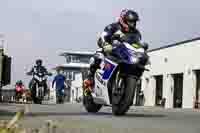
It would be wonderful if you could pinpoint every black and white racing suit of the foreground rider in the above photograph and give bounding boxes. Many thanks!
[88,22,142,81]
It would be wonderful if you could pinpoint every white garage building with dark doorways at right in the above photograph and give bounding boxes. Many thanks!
[142,38,200,108]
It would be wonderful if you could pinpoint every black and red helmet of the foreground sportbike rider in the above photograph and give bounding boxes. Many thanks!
[121,9,139,29]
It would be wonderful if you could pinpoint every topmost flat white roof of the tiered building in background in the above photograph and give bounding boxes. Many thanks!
[59,51,95,56]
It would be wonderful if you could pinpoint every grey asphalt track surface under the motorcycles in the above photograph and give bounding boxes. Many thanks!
[0,103,200,133]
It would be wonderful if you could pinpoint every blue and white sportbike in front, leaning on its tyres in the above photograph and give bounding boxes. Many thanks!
[83,35,149,115]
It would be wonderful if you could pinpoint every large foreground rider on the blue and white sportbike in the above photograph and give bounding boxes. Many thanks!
[83,9,148,91]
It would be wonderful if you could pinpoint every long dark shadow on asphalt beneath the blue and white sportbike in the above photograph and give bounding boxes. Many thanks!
[26,112,166,118]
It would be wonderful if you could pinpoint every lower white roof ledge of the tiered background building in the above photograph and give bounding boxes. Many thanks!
[54,63,90,69]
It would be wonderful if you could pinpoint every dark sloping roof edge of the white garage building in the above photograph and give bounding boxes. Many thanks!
[148,37,200,52]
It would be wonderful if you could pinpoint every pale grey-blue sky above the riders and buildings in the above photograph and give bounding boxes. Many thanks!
[0,0,200,83]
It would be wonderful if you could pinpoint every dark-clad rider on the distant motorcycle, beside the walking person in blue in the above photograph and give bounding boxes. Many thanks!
[27,59,49,95]
